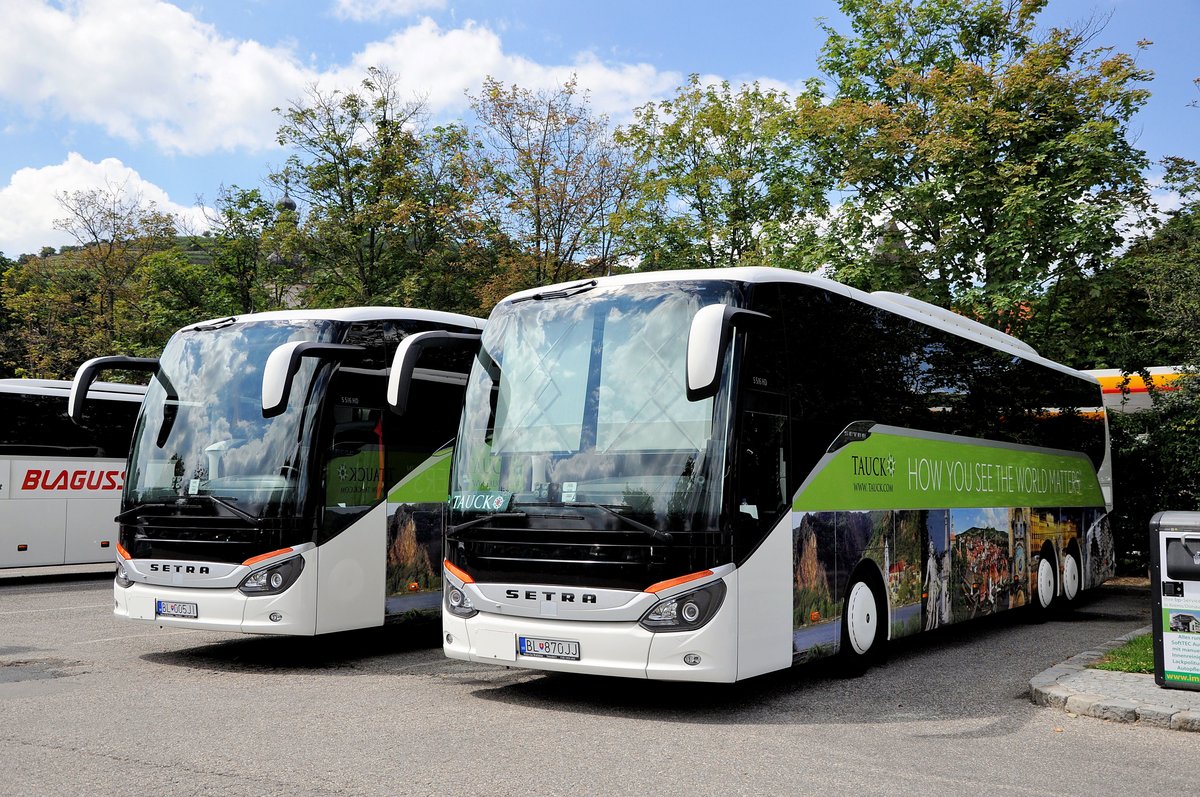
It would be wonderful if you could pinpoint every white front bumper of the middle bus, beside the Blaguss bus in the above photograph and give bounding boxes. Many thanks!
[113,579,317,636]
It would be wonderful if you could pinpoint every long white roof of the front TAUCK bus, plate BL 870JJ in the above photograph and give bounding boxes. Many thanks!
[500,266,1094,382]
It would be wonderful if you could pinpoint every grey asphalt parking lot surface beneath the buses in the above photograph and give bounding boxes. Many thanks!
[0,574,1196,796]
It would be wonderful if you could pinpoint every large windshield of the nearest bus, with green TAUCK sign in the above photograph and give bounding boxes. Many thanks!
[451,282,732,531]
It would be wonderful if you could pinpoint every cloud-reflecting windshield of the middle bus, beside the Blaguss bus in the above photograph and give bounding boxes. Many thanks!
[125,320,336,519]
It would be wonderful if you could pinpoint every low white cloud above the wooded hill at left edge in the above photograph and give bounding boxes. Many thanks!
[0,152,205,258]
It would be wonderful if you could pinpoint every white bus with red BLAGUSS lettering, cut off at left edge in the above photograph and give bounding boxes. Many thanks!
[0,379,145,568]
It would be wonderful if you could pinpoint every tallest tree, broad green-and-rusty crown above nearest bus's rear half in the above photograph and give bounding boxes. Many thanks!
[818,0,1151,346]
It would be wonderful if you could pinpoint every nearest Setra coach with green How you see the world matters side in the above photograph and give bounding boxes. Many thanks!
[417,268,1114,682]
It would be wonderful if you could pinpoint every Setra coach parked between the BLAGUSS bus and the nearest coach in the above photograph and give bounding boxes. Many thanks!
[76,307,482,635]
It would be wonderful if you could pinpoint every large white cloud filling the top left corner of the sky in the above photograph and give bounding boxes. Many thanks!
[0,0,316,155]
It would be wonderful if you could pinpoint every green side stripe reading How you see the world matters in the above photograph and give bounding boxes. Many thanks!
[792,426,1104,511]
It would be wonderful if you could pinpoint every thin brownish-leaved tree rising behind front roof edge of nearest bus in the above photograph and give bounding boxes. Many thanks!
[472,78,632,304]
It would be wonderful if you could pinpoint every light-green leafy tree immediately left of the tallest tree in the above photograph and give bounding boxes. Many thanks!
[618,74,827,270]
